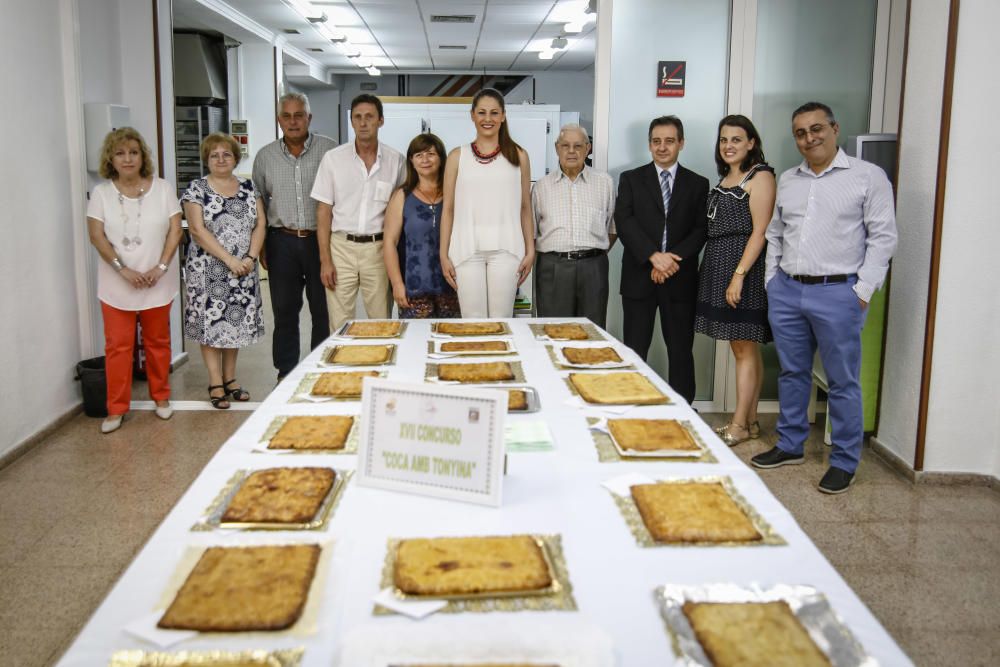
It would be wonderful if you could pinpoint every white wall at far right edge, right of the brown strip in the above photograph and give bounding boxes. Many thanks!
[920,0,1000,474]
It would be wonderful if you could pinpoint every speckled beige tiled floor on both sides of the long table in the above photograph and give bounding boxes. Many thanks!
[0,306,1000,667]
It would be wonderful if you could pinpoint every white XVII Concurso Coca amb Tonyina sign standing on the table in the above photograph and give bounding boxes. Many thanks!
[355,378,507,507]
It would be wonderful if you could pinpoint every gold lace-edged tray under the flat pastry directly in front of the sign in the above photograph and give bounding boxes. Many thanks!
[373,535,576,615]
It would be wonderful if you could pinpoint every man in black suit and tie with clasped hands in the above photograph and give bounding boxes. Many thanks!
[615,116,708,403]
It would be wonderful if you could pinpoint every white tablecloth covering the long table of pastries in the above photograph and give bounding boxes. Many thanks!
[59,318,910,667]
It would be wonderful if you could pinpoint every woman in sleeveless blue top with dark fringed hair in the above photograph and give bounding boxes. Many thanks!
[382,132,459,319]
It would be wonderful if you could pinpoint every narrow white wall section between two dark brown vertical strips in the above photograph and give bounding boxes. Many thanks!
[876,0,954,466]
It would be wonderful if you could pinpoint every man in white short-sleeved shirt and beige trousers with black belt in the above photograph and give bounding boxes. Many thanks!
[310,94,406,331]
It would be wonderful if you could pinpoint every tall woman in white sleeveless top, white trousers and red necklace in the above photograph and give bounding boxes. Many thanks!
[441,88,535,317]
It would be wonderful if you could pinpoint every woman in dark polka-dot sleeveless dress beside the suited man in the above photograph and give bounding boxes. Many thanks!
[695,115,775,446]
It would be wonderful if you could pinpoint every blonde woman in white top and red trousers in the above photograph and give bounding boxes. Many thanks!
[87,127,183,433]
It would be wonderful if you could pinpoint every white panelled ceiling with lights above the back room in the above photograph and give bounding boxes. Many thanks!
[173,0,596,74]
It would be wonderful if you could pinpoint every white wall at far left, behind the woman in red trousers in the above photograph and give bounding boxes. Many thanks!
[0,0,84,455]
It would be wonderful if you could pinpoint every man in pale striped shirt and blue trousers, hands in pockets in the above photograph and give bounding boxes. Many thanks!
[751,102,896,493]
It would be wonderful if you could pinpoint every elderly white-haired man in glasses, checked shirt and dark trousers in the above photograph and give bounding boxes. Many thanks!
[531,123,615,327]
